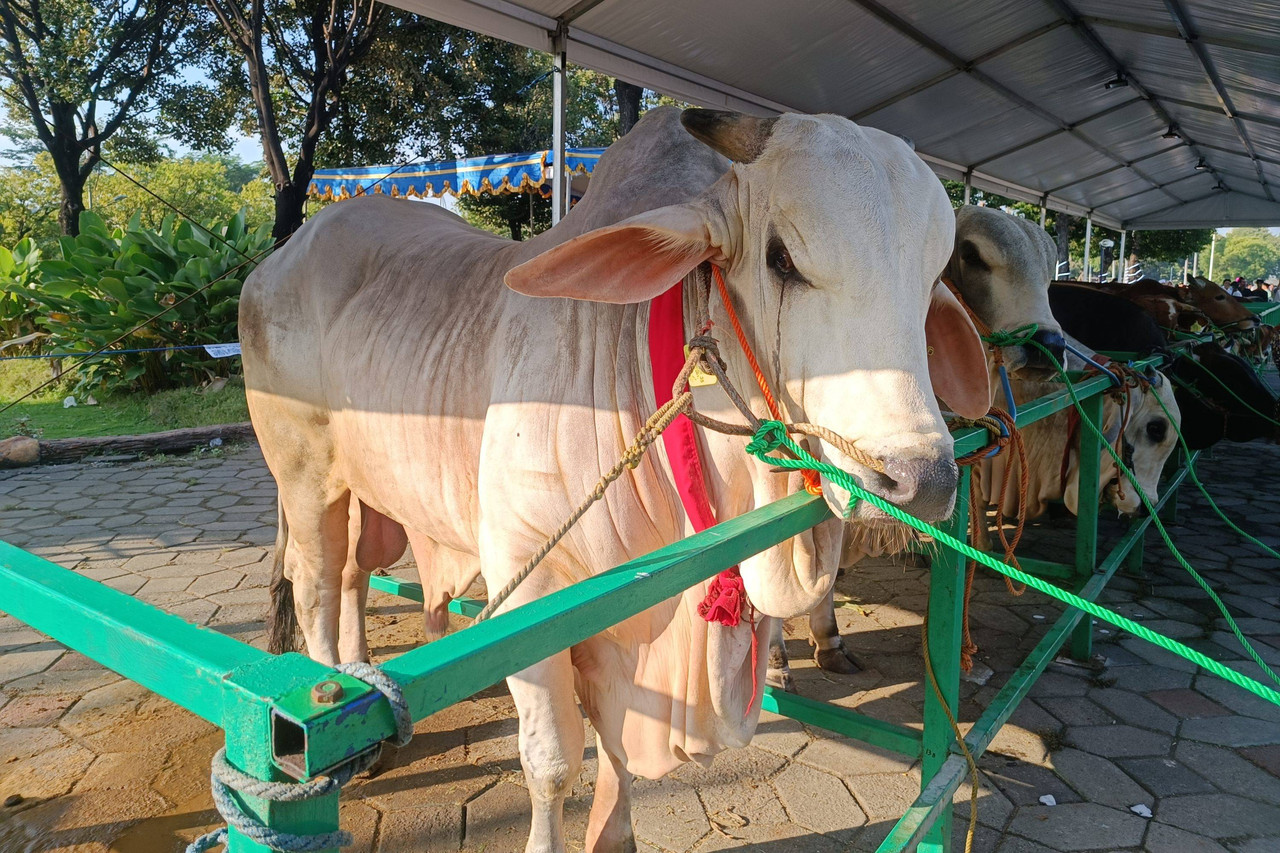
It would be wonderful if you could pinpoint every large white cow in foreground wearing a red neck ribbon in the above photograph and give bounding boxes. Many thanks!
[241,110,988,852]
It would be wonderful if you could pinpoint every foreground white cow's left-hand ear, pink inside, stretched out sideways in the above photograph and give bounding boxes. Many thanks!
[506,205,719,304]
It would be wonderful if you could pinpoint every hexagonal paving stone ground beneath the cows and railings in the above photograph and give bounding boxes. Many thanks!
[0,427,1280,853]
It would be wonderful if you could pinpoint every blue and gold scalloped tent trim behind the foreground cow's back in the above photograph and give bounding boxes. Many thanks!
[307,149,604,201]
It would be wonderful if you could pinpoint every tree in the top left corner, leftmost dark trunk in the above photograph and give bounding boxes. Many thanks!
[0,0,193,234]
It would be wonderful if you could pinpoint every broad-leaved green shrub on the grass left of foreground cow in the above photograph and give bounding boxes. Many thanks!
[16,211,271,394]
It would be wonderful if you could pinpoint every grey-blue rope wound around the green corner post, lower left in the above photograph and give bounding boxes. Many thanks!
[187,662,413,853]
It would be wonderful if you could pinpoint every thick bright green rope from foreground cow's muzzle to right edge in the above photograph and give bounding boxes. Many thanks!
[746,417,1280,706]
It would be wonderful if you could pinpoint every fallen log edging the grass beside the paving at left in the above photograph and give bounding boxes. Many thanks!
[0,421,255,467]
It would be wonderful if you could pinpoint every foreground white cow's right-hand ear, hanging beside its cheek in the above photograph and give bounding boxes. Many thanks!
[924,284,991,419]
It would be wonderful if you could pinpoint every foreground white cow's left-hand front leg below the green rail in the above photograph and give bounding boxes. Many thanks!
[507,651,585,853]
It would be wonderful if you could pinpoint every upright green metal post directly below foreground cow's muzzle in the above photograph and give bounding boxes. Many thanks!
[919,467,970,853]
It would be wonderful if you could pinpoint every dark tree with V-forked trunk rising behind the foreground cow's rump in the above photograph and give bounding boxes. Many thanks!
[205,0,389,240]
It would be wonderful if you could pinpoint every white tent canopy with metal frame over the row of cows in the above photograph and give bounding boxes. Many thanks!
[393,0,1280,229]
